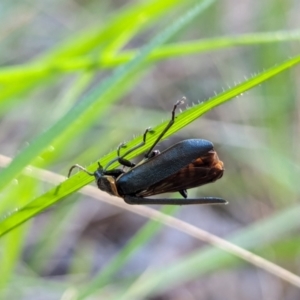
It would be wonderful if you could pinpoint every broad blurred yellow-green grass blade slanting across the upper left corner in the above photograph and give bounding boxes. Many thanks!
[0,0,182,104]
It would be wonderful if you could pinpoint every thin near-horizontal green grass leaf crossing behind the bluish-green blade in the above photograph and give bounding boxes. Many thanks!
[0,28,300,83]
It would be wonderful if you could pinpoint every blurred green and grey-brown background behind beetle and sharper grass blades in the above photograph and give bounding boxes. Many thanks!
[0,0,300,300]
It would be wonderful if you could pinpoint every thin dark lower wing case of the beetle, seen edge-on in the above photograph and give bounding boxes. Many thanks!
[123,195,228,205]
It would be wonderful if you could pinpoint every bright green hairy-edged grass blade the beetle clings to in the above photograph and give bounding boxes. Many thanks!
[0,52,300,236]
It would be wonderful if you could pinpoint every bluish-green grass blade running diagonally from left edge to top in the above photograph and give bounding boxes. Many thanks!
[0,0,216,190]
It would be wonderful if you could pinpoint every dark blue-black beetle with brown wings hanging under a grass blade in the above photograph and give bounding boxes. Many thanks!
[68,100,227,205]
